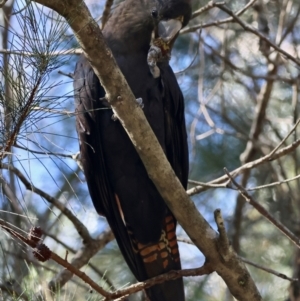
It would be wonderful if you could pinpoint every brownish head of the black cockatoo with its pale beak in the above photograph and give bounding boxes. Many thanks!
[104,0,191,53]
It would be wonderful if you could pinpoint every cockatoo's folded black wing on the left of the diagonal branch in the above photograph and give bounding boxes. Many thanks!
[74,56,145,274]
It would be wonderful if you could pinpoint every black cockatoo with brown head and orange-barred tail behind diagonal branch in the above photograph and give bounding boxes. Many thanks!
[74,0,191,301]
